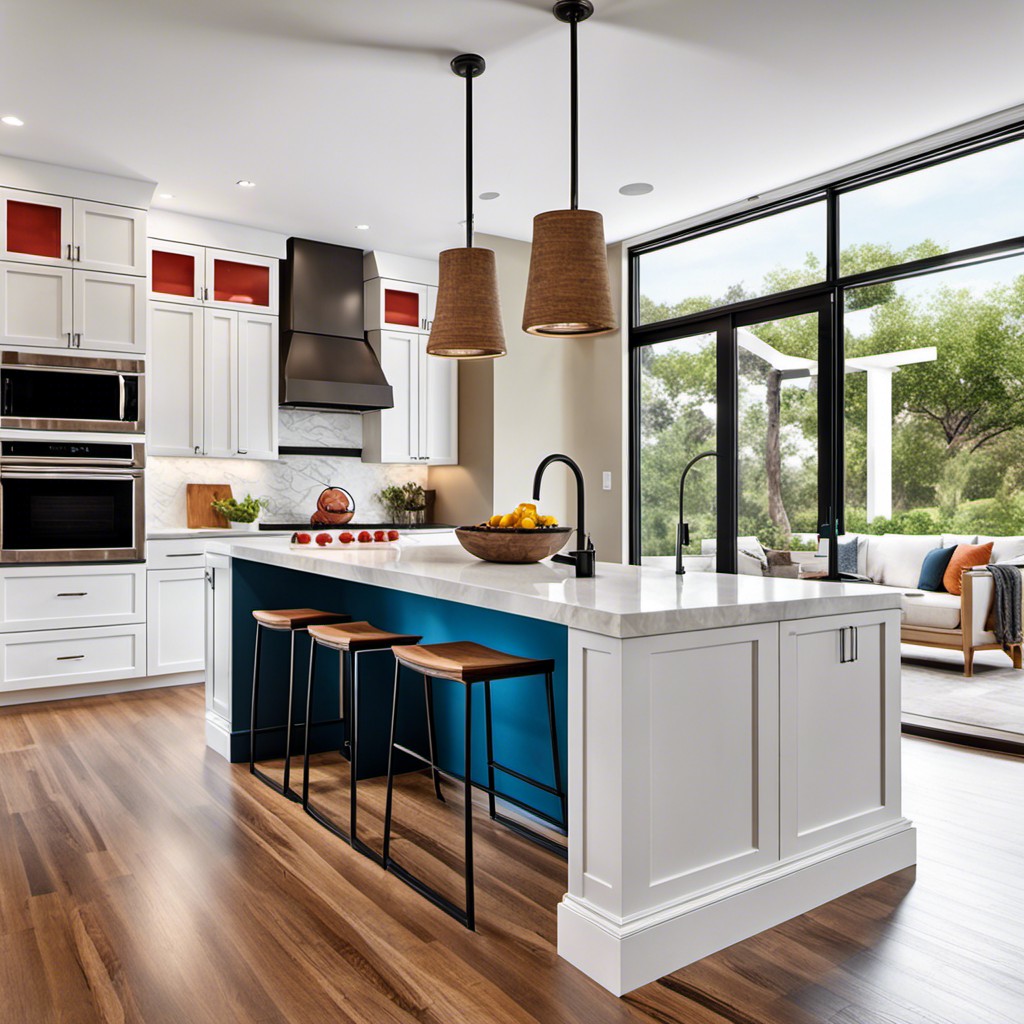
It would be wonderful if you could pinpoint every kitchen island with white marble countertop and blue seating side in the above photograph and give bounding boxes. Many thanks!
[199,537,915,994]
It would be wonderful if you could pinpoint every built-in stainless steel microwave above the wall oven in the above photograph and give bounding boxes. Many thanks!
[0,351,145,434]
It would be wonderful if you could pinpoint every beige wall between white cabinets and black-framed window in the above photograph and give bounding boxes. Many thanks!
[430,234,626,561]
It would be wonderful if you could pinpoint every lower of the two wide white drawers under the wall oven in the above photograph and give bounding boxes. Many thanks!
[0,623,145,691]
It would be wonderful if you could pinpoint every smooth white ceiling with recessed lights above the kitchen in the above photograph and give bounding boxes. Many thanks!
[0,0,1024,256]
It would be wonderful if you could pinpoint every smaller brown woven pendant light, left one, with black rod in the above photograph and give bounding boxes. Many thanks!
[427,53,505,359]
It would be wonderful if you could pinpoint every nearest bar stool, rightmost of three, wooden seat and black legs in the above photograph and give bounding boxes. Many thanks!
[383,641,566,931]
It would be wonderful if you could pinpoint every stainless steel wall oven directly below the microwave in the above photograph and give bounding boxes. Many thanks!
[0,440,145,564]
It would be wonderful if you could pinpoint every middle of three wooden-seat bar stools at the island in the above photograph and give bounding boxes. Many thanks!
[302,622,434,863]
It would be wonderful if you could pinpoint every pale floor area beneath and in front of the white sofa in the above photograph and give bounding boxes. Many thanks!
[902,644,1024,740]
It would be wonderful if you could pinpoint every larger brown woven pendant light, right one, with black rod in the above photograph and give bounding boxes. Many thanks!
[522,0,615,338]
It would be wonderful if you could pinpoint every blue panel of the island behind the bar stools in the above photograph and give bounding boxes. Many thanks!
[231,559,568,816]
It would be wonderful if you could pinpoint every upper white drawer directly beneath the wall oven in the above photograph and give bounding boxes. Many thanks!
[0,565,145,632]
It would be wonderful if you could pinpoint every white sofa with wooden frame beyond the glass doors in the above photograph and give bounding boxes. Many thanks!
[843,534,1024,676]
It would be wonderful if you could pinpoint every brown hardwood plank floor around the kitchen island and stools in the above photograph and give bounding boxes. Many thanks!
[0,687,1024,1024]
